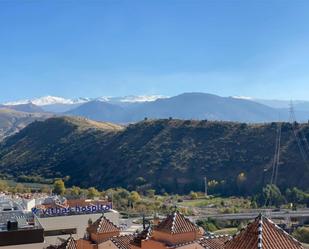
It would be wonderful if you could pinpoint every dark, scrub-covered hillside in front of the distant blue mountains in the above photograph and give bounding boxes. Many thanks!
[0,117,309,194]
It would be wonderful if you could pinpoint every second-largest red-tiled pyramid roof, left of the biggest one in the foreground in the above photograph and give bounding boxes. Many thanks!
[154,211,199,234]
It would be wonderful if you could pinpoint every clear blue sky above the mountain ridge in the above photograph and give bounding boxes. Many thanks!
[0,0,309,102]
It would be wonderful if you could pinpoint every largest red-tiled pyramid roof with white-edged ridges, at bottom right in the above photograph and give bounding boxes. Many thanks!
[225,215,303,249]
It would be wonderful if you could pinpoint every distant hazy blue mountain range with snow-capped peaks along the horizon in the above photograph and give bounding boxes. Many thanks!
[0,93,309,139]
